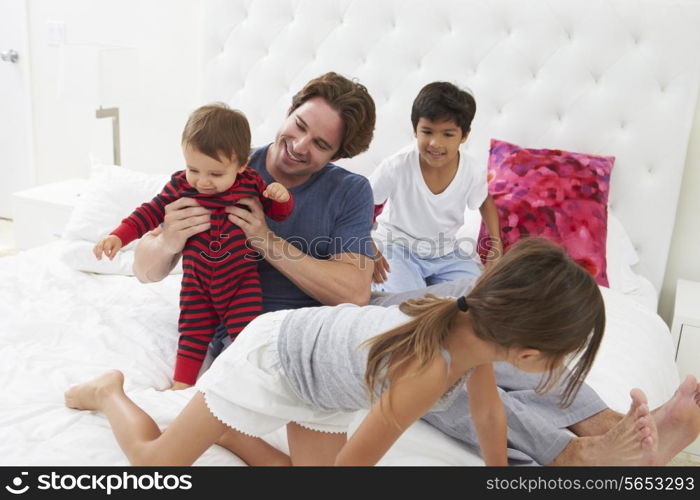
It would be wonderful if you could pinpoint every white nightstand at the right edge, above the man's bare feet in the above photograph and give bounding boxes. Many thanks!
[671,280,700,456]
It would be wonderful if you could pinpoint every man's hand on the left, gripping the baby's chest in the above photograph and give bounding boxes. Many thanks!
[161,198,211,255]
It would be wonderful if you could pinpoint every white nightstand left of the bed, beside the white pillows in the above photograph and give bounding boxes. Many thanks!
[12,179,88,250]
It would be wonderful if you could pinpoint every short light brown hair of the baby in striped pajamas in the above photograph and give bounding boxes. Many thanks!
[182,102,250,165]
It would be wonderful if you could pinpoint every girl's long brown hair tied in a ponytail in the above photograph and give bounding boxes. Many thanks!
[365,238,605,414]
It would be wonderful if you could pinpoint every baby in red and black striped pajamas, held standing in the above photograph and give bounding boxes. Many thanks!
[93,103,294,389]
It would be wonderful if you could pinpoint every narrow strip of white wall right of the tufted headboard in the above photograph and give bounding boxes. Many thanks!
[659,94,700,326]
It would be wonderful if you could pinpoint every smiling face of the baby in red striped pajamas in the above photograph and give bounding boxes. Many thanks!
[182,144,246,194]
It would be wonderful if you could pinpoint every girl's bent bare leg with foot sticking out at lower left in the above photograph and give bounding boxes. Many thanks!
[65,370,227,465]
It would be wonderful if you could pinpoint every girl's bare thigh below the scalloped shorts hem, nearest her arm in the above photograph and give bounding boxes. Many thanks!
[287,422,348,466]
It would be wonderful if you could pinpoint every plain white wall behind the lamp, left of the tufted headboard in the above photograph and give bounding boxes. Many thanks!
[28,0,200,180]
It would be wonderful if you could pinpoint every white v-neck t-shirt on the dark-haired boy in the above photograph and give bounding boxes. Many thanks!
[369,144,488,259]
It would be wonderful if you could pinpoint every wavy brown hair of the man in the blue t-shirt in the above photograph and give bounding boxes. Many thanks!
[289,71,376,158]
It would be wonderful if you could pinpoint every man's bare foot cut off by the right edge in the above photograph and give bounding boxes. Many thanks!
[653,375,700,465]
